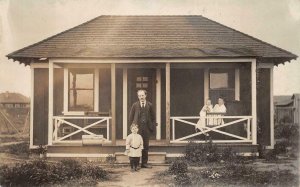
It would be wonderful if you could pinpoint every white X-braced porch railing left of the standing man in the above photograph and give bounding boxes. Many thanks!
[52,116,111,143]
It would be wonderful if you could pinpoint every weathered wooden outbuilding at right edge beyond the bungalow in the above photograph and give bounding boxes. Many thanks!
[274,94,300,125]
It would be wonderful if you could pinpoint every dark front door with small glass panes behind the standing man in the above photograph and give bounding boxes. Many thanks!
[128,69,156,139]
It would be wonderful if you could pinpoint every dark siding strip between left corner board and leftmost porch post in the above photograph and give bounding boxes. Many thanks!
[33,68,49,145]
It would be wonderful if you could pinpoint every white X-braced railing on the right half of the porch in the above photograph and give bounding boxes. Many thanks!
[171,115,255,143]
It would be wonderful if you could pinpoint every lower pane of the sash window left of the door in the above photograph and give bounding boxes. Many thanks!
[69,90,94,111]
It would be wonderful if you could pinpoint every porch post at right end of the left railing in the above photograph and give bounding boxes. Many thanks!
[111,63,116,145]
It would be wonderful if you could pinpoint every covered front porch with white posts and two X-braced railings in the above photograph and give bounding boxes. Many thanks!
[31,59,257,161]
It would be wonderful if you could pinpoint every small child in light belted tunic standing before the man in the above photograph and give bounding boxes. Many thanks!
[125,124,144,172]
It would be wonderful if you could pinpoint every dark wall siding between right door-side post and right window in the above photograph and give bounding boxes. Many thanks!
[170,69,204,137]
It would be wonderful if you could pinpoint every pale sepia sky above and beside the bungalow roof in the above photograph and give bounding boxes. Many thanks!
[0,0,300,96]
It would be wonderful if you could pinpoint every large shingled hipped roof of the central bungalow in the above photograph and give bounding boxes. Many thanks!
[7,16,297,63]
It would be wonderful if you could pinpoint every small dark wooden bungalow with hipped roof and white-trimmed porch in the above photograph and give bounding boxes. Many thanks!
[7,16,297,160]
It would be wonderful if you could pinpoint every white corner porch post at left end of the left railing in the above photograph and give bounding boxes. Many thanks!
[48,59,54,145]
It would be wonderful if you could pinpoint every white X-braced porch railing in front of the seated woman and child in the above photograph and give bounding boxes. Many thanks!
[171,115,253,143]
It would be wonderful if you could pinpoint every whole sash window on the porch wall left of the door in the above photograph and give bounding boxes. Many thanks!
[69,68,94,111]
